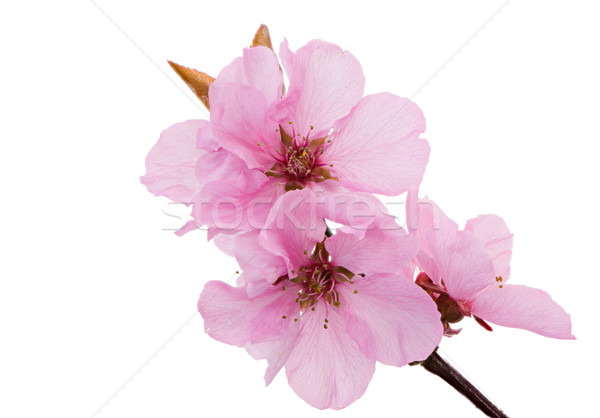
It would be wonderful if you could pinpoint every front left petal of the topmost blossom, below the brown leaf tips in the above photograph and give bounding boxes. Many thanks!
[209,82,281,170]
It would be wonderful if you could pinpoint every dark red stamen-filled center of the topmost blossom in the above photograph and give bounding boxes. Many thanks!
[265,122,337,191]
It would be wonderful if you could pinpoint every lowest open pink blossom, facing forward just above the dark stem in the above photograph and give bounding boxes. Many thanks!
[198,189,443,409]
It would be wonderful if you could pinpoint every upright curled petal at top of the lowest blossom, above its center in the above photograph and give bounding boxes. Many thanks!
[260,189,326,277]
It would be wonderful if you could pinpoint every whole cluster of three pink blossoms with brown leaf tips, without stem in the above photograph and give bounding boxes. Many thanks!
[141,26,572,409]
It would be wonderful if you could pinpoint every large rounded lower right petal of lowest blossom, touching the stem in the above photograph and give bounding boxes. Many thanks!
[340,274,444,366]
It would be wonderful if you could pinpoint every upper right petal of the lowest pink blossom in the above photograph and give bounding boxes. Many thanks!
[325,229,418,275]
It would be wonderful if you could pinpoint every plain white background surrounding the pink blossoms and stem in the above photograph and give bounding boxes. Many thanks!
[0,0,600,418]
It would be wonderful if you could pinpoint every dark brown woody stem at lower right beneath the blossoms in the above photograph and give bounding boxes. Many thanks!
[420,348,508,418]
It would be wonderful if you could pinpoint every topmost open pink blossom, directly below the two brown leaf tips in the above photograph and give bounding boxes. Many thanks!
[142,36,429,236]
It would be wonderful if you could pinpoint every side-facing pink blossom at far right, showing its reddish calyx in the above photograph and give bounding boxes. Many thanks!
[408,193,574,339]
